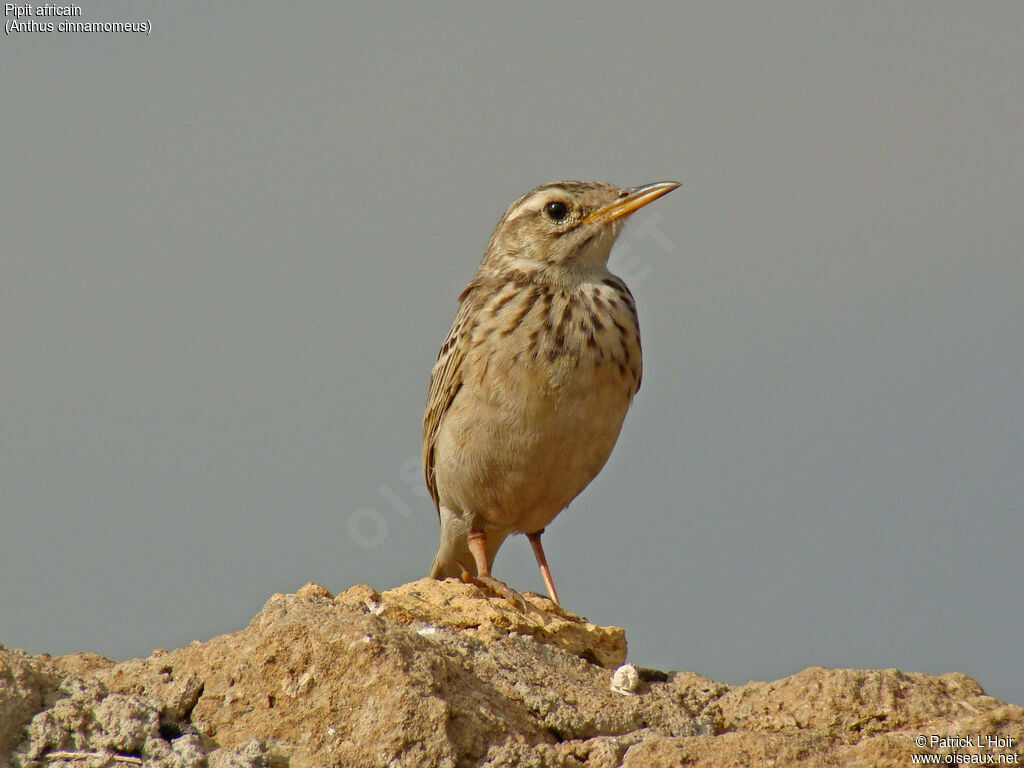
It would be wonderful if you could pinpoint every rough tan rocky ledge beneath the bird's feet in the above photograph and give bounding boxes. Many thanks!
[0,579,1024,768]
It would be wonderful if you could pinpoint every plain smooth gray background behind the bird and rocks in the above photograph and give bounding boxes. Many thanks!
[0,2,1024,702]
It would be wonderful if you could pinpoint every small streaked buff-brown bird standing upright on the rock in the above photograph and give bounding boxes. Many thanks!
[422,181,679,607]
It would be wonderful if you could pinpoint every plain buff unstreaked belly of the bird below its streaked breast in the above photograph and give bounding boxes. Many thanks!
[435,355,636,532]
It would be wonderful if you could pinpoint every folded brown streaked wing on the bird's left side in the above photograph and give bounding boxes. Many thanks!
[423,283,477,515]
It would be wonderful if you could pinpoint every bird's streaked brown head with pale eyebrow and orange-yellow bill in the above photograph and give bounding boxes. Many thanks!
[481,181,679,273]
